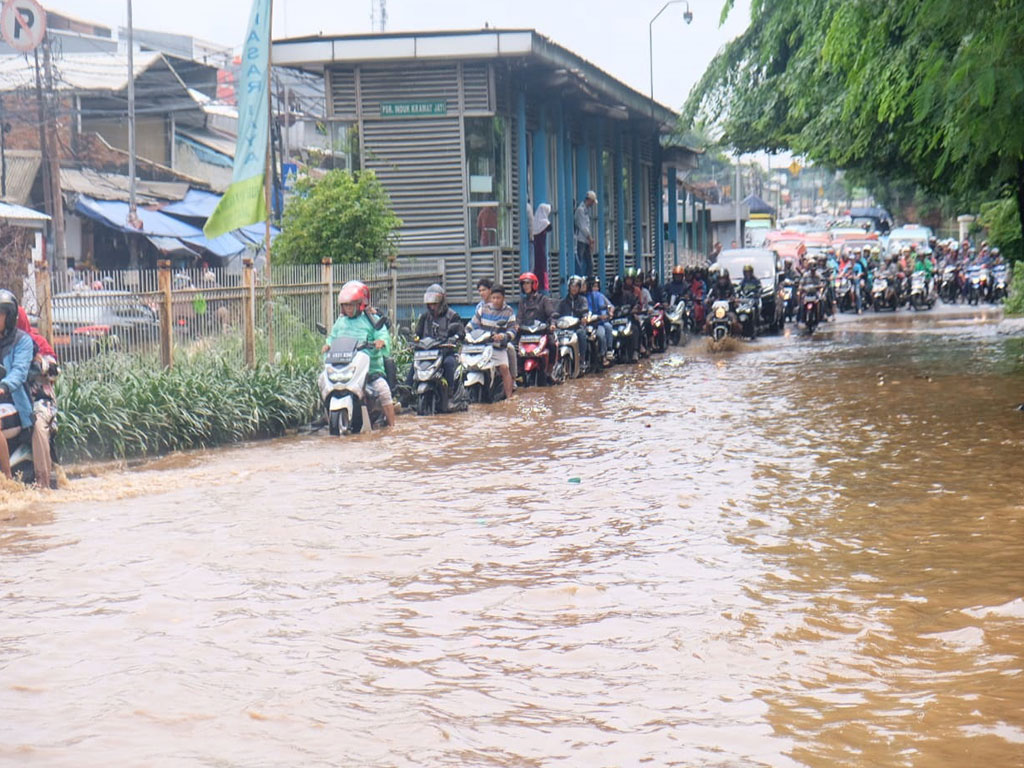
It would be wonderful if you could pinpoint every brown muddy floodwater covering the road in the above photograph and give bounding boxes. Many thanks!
[0,313,1024,768]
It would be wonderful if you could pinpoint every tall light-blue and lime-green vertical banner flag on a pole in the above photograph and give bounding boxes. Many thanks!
[203,0,271,239]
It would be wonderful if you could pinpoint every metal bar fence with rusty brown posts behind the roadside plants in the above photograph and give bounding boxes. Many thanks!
[35,259,444,366]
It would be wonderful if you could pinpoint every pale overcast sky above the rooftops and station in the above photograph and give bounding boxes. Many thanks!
[43,0,750,110]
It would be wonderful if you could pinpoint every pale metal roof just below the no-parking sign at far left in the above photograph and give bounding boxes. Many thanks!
[0,52,164,92]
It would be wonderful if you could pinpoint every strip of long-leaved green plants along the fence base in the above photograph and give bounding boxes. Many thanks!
[56,348,319,461]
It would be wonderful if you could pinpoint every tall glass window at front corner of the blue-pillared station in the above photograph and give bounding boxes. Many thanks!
[466,117,512,248]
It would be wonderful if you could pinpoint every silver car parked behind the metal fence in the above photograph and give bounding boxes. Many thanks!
[52,291,160,359]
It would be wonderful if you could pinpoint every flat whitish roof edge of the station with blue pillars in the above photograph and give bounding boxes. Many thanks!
[271,29,678,128]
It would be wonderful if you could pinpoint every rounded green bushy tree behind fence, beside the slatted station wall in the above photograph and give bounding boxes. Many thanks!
[274,170,401,264]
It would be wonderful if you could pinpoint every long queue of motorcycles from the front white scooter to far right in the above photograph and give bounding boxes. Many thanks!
[319,237,1009,434]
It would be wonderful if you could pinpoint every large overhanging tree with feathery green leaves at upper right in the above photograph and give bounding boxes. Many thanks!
[684,0,1024,255]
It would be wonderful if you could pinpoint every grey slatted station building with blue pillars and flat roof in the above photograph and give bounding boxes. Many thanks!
[272,29,696,304]
